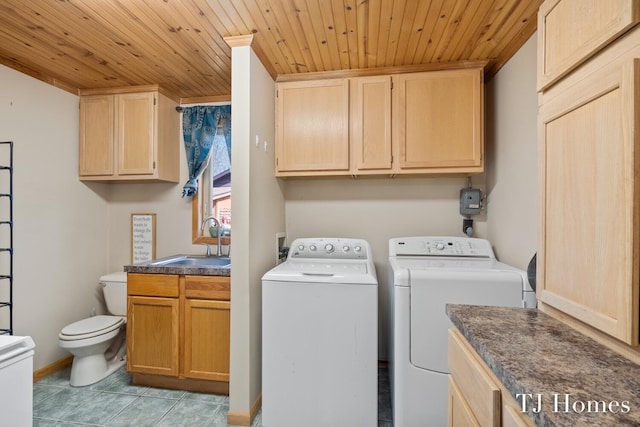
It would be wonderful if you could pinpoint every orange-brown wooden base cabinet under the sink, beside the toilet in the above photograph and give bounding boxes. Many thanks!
[127,273,231,392]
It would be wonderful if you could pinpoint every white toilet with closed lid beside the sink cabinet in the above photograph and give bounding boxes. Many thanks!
[58,271,127,387]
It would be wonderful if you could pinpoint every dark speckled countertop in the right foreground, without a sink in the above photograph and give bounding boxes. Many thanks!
[446,305,640,427]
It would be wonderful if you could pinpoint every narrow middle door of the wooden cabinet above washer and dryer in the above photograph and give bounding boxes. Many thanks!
[350,76,392,174]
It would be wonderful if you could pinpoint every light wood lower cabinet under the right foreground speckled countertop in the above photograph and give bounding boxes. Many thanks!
[448,329,534,427]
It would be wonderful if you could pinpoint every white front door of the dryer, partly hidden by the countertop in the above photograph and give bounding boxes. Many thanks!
[410,270,522,373]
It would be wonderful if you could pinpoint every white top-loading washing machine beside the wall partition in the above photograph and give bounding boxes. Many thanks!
[262,238,378,427]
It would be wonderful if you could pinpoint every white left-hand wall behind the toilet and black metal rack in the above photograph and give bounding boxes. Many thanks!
[0,66,109,369]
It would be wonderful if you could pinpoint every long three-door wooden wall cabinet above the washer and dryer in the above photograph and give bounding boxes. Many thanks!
[276,68,484,177]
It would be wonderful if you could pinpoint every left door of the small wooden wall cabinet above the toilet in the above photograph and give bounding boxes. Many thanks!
[79,95,115,176]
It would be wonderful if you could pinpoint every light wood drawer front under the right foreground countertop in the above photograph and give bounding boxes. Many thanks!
[449,329,501,427]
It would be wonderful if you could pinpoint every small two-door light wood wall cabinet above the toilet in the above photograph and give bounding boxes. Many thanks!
[79,87,180,182]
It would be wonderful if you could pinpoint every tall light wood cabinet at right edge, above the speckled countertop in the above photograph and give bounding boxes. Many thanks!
[537,0,640,346]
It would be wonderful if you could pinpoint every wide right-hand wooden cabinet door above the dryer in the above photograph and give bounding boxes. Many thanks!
[393,68,484,173]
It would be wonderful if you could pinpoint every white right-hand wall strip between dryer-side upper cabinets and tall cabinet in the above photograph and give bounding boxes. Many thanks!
[486,34,538,269]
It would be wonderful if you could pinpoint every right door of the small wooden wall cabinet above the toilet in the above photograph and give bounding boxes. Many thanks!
[116,92,156,175]
